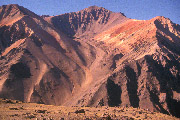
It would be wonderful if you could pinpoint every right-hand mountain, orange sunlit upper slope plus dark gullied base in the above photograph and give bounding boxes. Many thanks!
[92,17,180,116]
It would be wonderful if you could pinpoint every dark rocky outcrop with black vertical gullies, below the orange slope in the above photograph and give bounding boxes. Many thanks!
[103,55,179,116]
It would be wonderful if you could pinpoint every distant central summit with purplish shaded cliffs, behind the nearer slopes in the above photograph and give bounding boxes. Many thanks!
[44,6,128,37]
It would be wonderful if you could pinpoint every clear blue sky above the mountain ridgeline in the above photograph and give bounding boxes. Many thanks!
[0,0,180,24]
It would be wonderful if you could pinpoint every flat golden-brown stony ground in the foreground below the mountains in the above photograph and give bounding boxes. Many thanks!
[0,99,178,120]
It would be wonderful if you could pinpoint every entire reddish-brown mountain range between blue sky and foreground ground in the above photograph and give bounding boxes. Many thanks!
[0,5,180,117]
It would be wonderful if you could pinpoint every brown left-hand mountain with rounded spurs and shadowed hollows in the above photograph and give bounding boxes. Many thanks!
[0,5,95,105]
